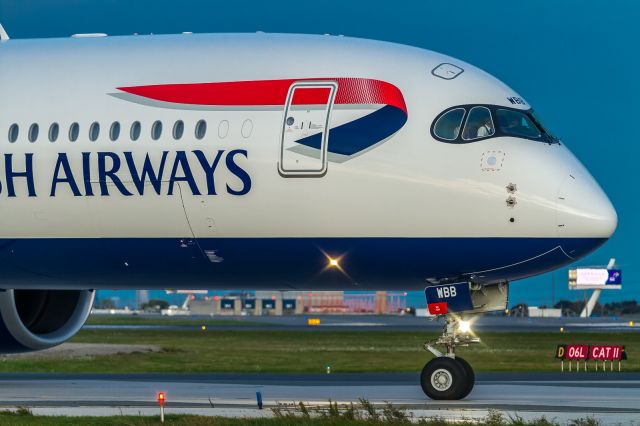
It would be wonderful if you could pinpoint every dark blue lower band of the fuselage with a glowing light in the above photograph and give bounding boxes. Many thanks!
[0,237,606,290]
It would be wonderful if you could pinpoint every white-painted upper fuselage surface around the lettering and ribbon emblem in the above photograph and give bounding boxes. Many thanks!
[0,34,616,292]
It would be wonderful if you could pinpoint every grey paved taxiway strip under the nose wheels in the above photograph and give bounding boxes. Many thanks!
[0,372,640,425]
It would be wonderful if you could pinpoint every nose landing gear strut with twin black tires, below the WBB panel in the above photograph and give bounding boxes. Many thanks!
[420,314,480,400]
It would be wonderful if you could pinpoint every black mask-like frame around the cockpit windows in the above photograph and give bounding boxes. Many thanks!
[430,104,560,145]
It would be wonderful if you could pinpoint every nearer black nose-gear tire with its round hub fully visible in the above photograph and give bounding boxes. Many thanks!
[420,356,468,400]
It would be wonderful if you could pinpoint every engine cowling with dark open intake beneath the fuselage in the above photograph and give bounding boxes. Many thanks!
[0,290,95,353]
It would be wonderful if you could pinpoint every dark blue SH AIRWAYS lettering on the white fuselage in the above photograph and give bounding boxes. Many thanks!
[0,149,251,197]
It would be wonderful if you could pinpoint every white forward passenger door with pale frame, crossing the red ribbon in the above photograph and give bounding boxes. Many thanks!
[278,81,338,177]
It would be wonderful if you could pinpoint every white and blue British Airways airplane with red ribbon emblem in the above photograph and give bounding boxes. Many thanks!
[0,25,617,399]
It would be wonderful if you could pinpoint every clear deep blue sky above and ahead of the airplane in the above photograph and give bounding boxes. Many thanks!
[0,0,640,305]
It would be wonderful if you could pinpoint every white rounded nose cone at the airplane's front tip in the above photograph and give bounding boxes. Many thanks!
[556,170,618,243]
